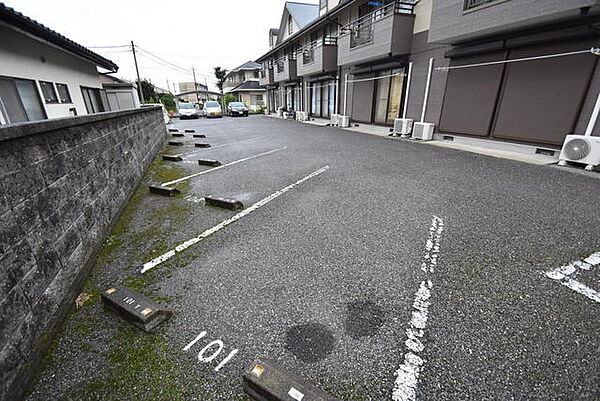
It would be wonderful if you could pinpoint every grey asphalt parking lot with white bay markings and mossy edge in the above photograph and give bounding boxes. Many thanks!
[27,116,600,400]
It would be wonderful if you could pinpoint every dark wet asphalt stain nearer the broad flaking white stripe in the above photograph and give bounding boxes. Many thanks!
[346,301,385,339]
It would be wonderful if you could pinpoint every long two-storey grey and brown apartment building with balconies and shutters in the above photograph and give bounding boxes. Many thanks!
[257,0,600,149]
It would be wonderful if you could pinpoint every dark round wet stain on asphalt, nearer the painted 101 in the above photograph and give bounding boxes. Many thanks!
[285,323,335,363]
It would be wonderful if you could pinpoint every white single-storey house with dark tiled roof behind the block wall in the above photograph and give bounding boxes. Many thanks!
[0,3,118,124]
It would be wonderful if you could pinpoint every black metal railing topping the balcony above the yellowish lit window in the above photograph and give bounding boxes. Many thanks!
[340,0,414,48]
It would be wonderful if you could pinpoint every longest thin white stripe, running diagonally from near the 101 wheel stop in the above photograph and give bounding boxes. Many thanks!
[141,166,329,273]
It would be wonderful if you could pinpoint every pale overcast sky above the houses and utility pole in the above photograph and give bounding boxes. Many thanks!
[3,0,318,91]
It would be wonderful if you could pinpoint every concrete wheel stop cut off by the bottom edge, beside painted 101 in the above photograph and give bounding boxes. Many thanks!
[242,358,341,401]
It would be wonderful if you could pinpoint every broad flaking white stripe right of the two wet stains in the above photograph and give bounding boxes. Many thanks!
[392,216,444,401]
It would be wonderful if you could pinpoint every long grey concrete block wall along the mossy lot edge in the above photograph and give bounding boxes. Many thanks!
[0,104,166,400]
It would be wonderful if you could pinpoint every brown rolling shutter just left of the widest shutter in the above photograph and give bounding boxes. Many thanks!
[440,51,506,136]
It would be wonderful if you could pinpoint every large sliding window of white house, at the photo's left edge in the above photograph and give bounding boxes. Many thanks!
[0,77,46,124]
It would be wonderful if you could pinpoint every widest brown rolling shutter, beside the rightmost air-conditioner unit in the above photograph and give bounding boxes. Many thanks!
[492,40,597,145]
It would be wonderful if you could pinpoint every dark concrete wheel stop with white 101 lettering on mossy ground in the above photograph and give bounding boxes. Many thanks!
[100,286,173,332]
